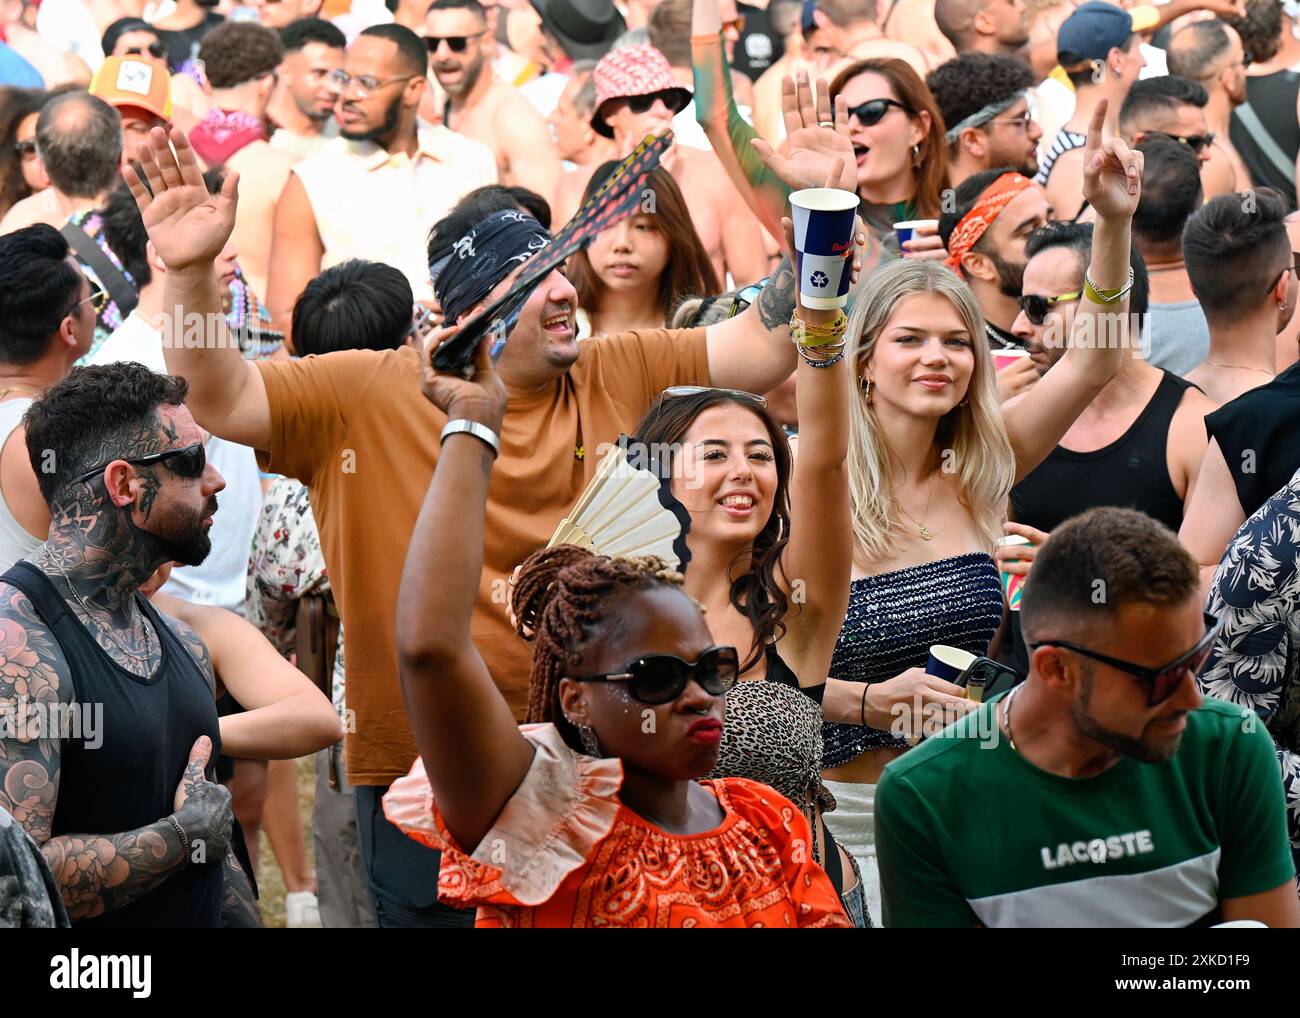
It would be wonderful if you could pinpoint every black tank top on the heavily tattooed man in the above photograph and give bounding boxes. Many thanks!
[0,562,221,928]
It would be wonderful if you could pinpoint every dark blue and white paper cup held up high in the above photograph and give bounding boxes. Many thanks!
[790,187,858,311]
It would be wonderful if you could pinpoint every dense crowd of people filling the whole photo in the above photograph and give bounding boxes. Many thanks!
[0,0,1300,928]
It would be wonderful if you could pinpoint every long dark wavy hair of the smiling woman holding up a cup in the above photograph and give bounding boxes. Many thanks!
[636,389,793,672]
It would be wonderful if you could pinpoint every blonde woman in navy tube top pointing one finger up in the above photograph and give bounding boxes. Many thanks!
[816,100,1141,925]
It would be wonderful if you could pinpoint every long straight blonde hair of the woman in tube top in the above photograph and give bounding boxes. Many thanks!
[846,259,1015,560]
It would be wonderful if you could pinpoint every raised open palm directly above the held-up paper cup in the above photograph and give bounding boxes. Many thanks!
[753,68,858,191]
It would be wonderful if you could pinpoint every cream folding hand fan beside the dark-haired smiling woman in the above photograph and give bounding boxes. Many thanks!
[546,436,690,572]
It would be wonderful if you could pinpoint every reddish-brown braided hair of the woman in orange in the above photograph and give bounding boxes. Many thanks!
[511,545,684,750]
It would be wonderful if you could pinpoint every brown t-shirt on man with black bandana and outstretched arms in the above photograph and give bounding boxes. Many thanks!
[257,329,709,785]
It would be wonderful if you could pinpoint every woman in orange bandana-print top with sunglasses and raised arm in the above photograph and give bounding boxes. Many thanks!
[384,329,848,927]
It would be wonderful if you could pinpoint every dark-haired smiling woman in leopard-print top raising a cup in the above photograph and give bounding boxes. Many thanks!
[636,205,867,926]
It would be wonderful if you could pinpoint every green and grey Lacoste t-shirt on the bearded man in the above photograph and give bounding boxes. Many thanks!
[875,698,1295,927]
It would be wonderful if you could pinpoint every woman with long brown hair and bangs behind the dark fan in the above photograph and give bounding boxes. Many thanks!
[567,163,722,339]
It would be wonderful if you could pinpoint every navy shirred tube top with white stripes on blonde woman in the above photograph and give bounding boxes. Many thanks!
[822,551,1002,767]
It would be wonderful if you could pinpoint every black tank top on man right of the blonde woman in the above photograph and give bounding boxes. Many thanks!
[1011,371,1191,532]
